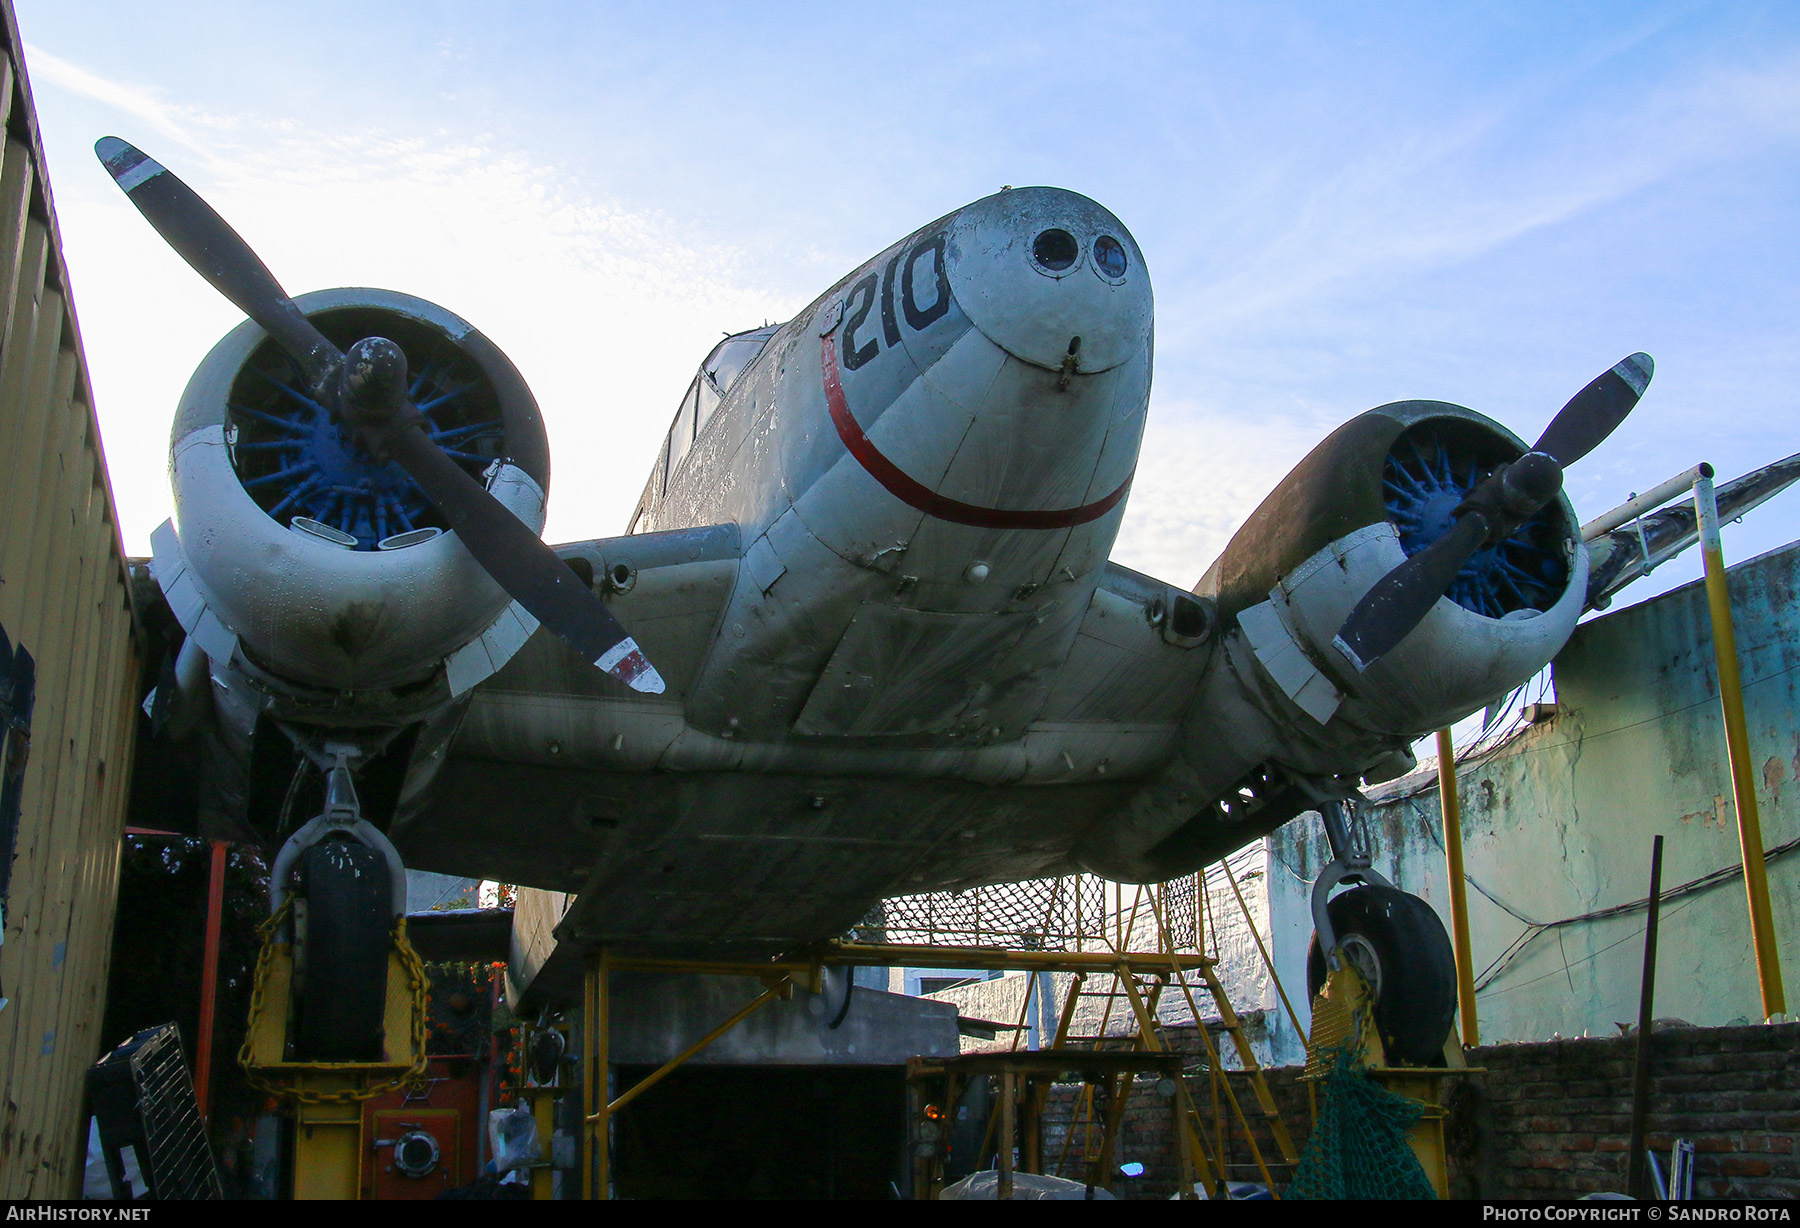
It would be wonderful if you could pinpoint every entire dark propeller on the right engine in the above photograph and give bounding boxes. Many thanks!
[1334,353,1656,670]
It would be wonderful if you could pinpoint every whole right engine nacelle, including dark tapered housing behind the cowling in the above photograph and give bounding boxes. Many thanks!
[1082,402,1588,880]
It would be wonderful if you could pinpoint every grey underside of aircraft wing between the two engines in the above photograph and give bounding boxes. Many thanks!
[396,547,1204,954]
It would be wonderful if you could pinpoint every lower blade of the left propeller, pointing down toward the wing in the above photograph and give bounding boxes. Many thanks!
[387,423,664,695]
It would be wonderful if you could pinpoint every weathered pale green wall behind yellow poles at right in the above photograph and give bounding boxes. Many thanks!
[1271,544,1800,1043]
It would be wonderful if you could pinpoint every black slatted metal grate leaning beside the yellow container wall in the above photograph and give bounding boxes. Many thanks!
[88,1023,225,1199]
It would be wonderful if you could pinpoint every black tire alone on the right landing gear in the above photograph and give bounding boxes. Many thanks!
[1307,886,1456,1066]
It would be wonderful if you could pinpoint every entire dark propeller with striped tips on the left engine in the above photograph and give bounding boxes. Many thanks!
[94,137,664,695]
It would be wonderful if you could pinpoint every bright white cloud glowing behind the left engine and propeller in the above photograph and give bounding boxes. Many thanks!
[43,77,801,551]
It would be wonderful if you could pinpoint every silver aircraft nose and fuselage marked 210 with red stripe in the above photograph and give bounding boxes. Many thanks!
[641,189,1150,745]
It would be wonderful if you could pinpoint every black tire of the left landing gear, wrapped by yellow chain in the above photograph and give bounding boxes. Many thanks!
[293,841,394,1062]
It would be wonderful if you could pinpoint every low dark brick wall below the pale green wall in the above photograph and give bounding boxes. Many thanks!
[1022,1025,1800,1199]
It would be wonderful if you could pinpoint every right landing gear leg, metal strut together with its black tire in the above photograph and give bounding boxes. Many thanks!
[1307,801,1456,1066]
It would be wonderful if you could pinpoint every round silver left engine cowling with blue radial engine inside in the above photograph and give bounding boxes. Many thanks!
[155,288,549,693]
